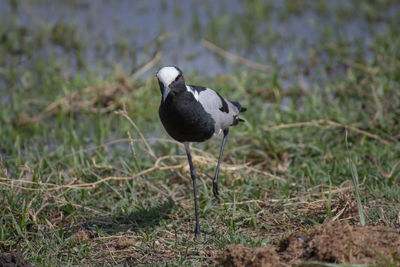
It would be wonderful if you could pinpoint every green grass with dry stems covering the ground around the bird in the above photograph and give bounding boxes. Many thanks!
[0,1,400,266]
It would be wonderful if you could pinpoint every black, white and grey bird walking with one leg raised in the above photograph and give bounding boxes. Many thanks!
[156,65,246,238]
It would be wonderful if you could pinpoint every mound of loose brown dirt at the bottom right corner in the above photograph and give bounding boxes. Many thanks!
[220,222,400,266]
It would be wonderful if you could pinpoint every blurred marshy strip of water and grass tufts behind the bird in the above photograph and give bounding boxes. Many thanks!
[0,0,400,89]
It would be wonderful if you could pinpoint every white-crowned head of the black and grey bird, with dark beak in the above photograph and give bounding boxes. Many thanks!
[156,66,186,102]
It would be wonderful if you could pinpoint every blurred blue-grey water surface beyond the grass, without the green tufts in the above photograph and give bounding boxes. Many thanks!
[0,0,399,84]
